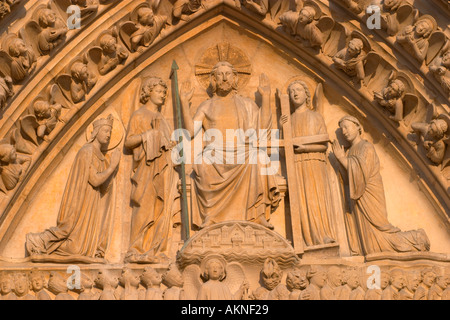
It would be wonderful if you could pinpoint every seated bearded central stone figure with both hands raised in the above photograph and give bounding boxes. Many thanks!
[180,57,281,229]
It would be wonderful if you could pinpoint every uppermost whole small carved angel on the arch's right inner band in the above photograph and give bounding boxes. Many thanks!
[280,1,334,48]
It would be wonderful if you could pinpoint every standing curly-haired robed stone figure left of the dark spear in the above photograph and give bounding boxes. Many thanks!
[125,77,180,263]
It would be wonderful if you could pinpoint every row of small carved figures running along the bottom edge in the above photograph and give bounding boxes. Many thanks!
[0,258,450,300]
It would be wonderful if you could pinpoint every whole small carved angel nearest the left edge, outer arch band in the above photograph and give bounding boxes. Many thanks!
[0,33,37,82]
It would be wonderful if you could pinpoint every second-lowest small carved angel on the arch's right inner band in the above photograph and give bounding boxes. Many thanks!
[374,72,419,122]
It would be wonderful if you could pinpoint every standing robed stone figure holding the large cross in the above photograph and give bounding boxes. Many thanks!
[281,80,336,246]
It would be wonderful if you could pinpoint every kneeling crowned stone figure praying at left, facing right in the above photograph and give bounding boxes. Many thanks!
[26,116,121,262]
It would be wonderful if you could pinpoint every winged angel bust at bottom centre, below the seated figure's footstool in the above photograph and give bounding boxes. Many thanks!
[184,254,253,300]
